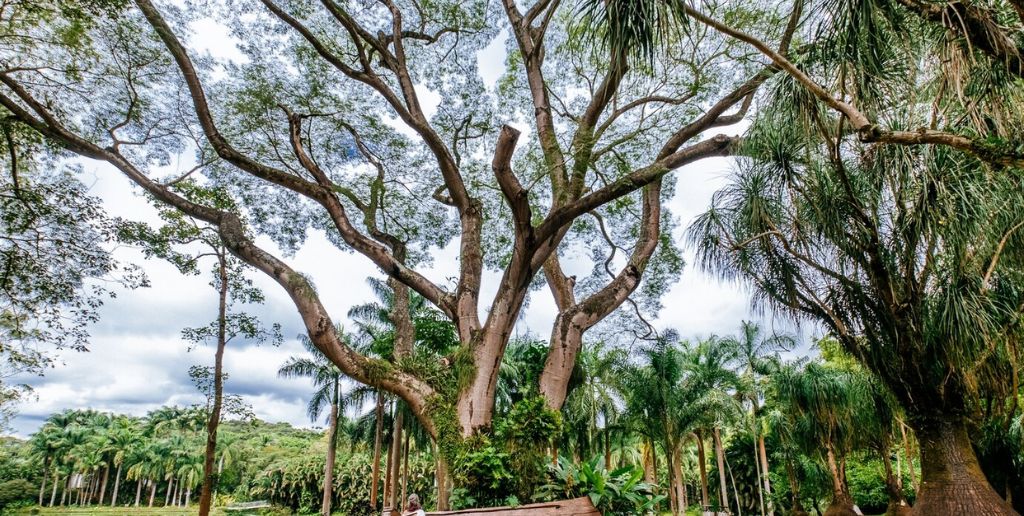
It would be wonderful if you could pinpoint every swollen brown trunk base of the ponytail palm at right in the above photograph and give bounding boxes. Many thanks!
[913,421,1018,516]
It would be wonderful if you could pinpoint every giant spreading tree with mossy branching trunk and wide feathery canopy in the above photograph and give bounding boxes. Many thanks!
[0,0,788,487]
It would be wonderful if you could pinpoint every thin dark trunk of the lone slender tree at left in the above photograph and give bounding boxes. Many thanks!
[199,250,228,516]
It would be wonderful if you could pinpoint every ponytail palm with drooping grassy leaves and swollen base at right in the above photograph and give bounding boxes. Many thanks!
[692,43,1024,514]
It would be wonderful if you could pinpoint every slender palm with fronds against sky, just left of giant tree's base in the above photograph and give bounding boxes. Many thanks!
[278,327,346,516]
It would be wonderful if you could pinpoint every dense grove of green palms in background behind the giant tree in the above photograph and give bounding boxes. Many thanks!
[8,319,1024,514]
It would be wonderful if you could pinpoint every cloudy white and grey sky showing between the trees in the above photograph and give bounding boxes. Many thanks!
[4,20,810,436]
